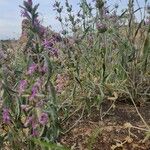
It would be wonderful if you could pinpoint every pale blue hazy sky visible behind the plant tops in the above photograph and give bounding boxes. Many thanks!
[0,0,150,39]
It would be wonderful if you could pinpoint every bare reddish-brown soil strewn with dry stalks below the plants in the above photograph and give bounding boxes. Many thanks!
[60,103,150,150]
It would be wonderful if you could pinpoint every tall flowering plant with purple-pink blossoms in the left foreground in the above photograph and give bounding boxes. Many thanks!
[1,0,60,149]
